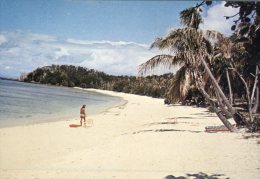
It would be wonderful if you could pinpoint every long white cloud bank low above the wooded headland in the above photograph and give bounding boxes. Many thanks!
[0,31,161,77]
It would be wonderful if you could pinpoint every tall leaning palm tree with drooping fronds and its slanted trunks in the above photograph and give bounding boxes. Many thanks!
[139,7,248,131]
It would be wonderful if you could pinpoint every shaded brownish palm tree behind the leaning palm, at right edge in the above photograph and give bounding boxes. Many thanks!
[215,28,259,122]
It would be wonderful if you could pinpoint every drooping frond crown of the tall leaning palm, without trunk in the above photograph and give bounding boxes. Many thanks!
[139,8,223,102]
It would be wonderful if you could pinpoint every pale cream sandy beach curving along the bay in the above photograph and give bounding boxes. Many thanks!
[0,90,260,179]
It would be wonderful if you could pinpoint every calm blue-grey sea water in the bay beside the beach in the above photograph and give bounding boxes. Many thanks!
[0,79,123,128]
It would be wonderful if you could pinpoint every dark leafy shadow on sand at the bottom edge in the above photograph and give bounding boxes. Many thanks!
[163,172,229,179]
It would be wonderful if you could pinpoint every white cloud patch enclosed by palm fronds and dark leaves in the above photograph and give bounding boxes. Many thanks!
[201,1,238,35]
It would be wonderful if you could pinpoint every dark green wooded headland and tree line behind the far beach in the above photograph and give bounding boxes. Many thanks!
[22,65,173,98]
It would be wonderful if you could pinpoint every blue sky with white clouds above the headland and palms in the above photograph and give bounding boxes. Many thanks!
[0,0,237,78]
